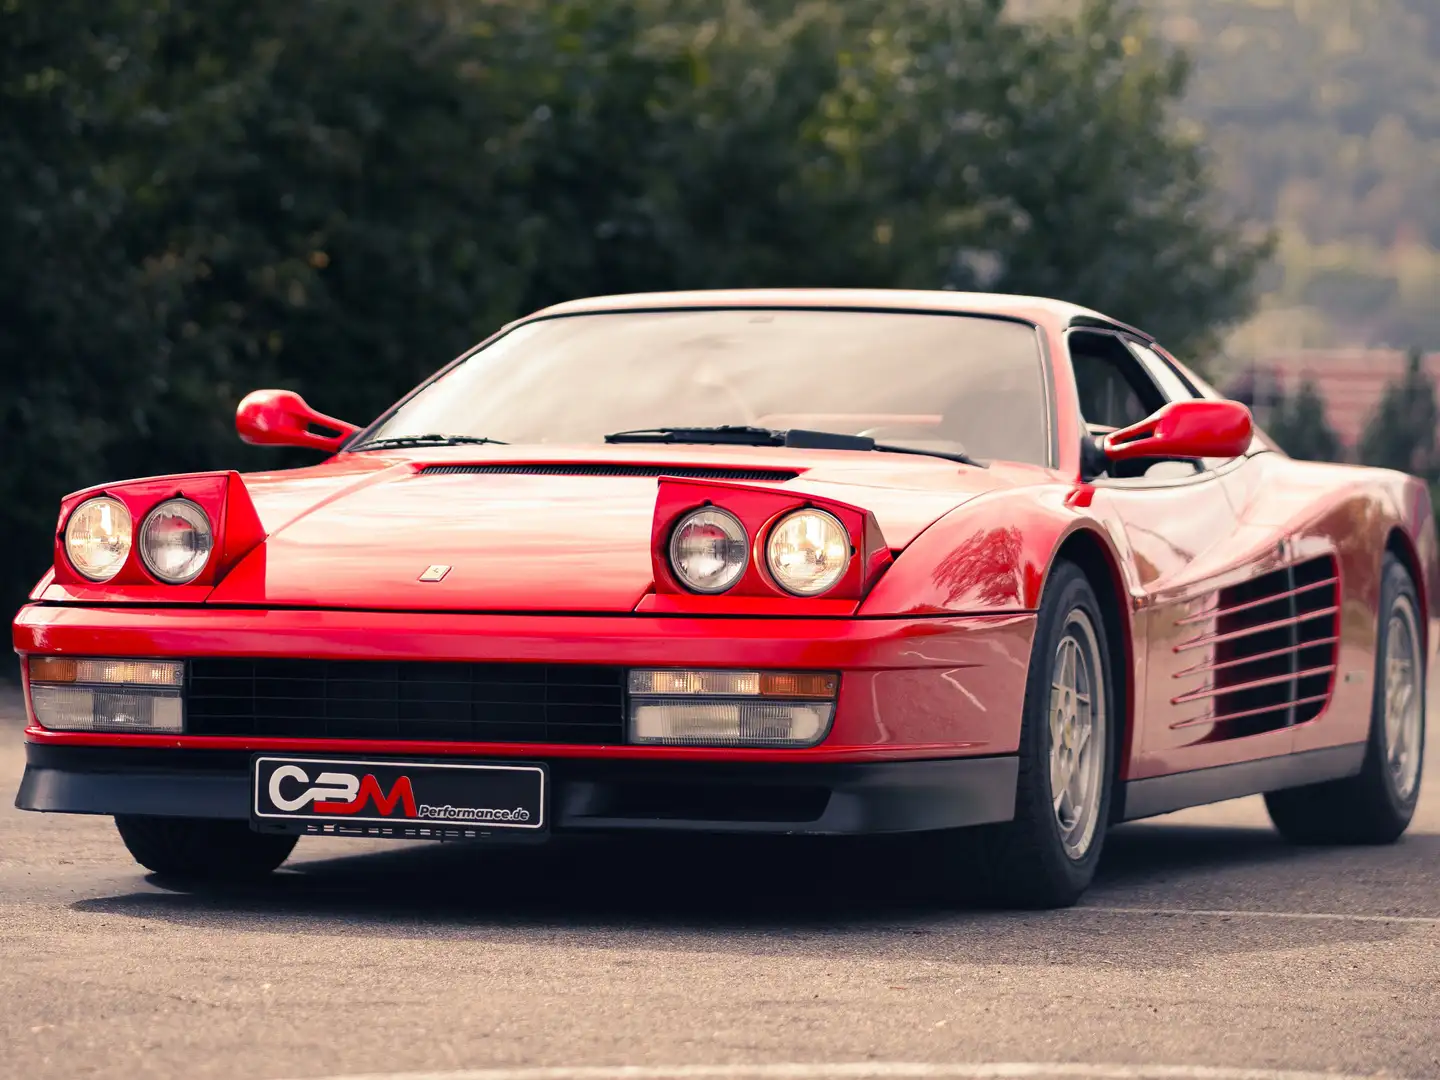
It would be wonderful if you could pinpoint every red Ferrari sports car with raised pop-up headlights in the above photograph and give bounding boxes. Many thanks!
[14,291,1440,906]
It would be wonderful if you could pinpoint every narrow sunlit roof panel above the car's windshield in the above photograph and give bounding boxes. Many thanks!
[517,288,1153,341]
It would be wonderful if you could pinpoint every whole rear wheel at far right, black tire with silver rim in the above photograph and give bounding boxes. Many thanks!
[1264,554,1426,844]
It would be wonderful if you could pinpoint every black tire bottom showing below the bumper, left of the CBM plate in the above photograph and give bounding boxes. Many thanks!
[115,816,298,881]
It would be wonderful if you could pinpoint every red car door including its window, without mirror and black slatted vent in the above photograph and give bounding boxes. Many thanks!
[1068,330,1293,779]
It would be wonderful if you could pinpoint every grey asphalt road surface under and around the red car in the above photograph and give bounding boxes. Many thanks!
[0,691,1440,1080]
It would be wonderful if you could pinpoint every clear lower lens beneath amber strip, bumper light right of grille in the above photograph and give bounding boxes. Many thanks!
[631,700,835,746]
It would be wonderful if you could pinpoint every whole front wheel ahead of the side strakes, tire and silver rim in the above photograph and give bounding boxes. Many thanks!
[976,562,1119,909]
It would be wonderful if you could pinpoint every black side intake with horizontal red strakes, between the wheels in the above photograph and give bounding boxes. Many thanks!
[1172,556,1339,737]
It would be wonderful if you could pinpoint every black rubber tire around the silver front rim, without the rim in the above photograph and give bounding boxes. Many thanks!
[976,562,1123,909]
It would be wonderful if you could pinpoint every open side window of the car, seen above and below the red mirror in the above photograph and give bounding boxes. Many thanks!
[1068,330,1202,480]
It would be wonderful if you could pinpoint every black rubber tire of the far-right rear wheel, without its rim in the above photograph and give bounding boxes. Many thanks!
[1264,553,1426,845]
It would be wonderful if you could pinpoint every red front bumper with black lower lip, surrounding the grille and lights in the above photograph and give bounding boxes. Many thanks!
[14,605,1034,835]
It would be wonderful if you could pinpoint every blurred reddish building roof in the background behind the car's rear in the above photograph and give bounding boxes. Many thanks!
[1225,348,1440,448]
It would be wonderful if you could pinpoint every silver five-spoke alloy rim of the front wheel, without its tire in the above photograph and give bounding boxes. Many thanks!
[1050,608,1109,861]
